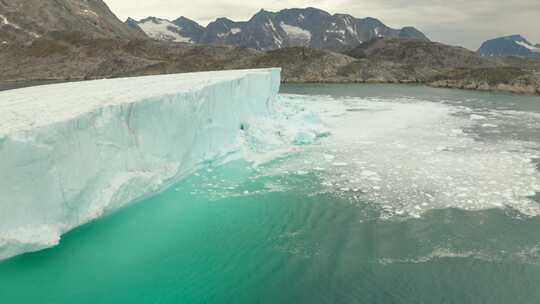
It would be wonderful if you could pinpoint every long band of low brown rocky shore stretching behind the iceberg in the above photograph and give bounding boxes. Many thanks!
[0,33,540,95]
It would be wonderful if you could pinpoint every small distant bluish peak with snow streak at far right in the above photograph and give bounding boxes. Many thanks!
[478,35,540,57]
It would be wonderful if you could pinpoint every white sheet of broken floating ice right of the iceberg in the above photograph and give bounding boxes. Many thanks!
[268,96,540,217]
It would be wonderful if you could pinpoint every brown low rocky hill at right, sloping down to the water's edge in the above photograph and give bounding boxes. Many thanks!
[339,39,540,94]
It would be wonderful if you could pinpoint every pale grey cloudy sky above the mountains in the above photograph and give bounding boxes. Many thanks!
[105,0,540,49]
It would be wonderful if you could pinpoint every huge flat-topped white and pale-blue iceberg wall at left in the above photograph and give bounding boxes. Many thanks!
[0,69,280,259]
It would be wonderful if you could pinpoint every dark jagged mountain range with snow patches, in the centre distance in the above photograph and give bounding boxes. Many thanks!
[126,8,429,51]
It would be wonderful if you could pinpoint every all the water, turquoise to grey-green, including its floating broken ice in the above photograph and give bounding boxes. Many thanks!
[0,85,540,304]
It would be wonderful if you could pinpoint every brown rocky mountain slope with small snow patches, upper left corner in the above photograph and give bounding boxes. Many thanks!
[0,0,145,44]
